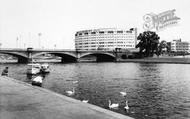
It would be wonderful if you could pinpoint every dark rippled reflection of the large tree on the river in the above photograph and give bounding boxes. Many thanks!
[132,63,163,118]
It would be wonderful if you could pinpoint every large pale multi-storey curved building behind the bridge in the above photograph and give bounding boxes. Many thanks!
[75,28,137,50]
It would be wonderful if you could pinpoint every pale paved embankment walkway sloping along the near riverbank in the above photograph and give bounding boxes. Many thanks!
[0,76,132,119]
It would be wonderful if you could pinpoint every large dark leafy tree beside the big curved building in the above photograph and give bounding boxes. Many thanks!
[136,31,160,57]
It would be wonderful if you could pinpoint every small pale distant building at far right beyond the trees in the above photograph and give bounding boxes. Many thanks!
[171,39,189,52]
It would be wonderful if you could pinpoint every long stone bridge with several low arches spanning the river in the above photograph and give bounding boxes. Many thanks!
[0,48,127,63]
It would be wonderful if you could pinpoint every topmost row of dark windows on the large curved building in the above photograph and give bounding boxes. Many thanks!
[75,30,132,36]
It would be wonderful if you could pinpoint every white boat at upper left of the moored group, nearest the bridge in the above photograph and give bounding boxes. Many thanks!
[27,63,41,75]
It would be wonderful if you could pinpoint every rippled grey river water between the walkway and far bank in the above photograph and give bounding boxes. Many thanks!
[0,63,190,119]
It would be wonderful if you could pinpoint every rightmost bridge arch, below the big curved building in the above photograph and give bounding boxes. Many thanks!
[80,52,116,62]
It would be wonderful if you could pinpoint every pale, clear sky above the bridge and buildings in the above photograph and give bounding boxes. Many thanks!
[0,0,190,49]
